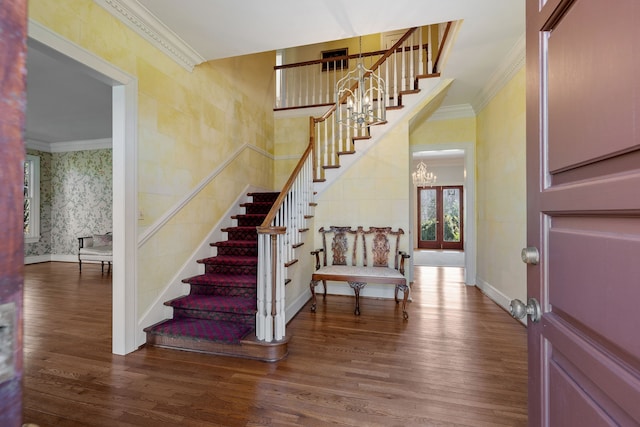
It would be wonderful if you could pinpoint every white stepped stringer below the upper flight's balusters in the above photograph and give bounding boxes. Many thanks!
[314,77,453,195]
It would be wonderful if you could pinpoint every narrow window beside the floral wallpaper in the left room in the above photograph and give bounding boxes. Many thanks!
[24,154,40,243]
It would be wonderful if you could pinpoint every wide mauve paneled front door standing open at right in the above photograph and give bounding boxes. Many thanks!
[527,0,640,426]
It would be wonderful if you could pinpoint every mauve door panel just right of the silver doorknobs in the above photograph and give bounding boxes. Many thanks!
[549,218,640,354]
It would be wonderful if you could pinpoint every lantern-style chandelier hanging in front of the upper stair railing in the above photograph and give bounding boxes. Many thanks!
[335,37,386,128]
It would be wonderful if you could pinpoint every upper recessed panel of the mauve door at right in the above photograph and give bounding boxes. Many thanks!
[547,1,640,173]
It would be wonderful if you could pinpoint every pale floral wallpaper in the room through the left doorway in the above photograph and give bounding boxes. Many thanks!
[25,149,113,256]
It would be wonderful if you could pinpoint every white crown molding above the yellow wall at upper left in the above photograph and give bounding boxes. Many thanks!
[94,0,206,72]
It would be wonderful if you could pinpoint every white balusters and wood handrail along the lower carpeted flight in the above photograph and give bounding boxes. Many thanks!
[256,141,314,342]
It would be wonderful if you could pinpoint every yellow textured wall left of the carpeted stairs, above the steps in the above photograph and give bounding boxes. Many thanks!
[29,0,275,314]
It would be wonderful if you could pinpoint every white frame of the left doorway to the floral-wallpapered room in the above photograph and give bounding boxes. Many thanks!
[28,19,138,355]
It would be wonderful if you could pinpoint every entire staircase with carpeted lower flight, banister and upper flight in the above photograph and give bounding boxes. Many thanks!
[144,23,450,361]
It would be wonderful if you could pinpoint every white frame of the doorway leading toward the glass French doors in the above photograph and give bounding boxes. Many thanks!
[409,142,477,286]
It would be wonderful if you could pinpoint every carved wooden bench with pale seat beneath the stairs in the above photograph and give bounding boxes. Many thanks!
[309,226,409,319]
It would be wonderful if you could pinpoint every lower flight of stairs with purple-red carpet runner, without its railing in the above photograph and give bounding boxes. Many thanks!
[144,193,286,361]
